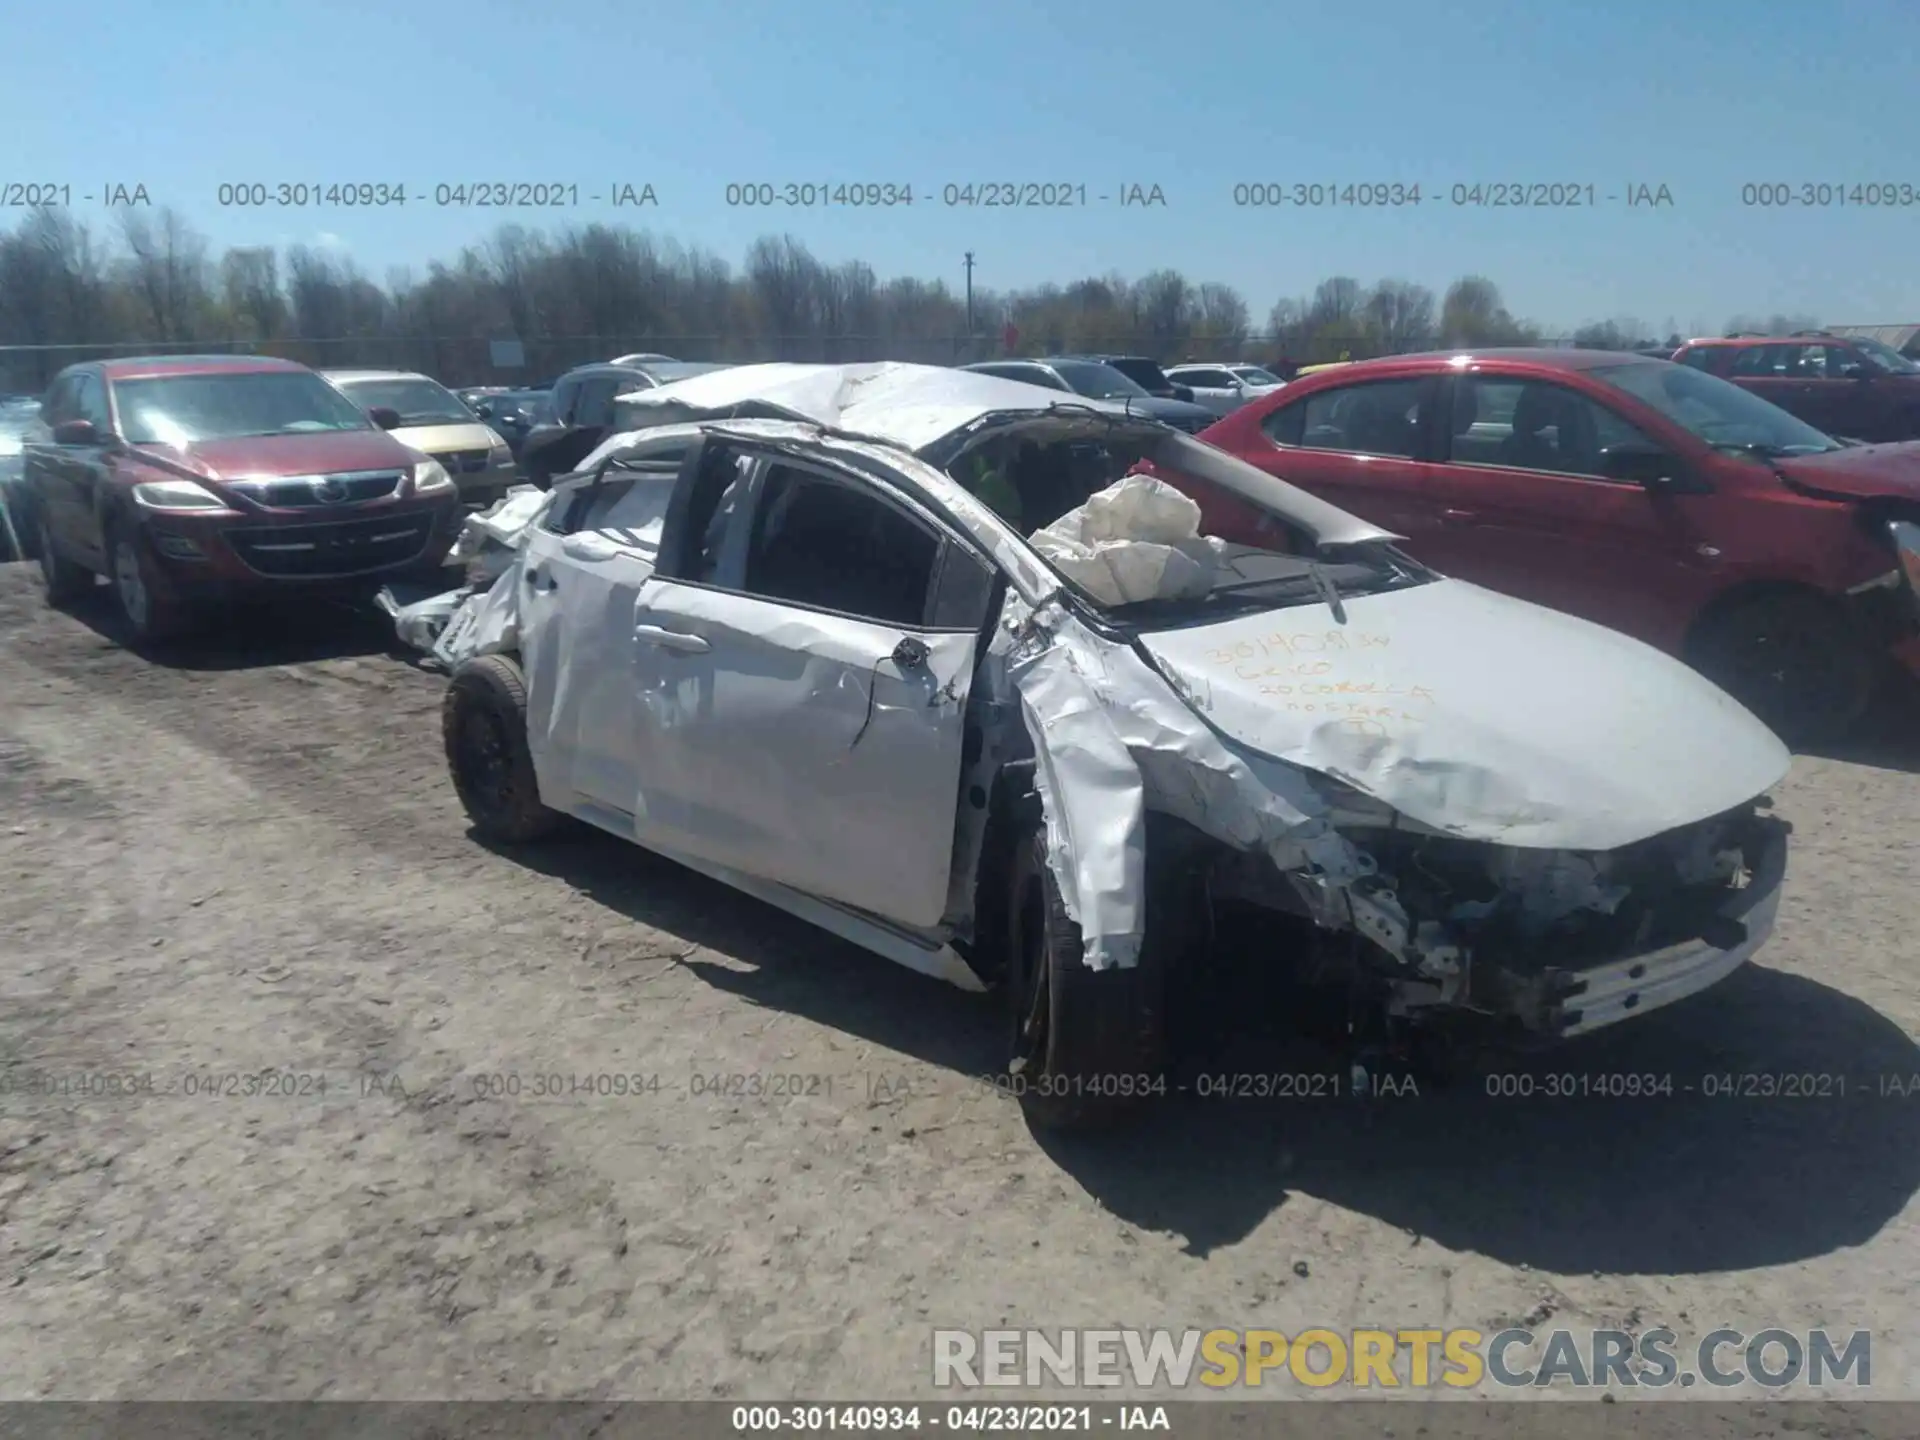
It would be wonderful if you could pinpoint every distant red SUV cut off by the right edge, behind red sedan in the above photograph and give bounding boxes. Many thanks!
[1672,330,1920,440]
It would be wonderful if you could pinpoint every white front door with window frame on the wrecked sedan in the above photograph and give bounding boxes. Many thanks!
[634,438,993,927]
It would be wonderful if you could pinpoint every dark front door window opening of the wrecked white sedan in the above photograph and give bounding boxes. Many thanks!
[743,465,941,628]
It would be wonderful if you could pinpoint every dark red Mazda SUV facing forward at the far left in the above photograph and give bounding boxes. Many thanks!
[23,355,461,639]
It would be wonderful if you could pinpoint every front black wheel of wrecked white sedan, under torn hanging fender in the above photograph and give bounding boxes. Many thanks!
[1006,828,1190,1129]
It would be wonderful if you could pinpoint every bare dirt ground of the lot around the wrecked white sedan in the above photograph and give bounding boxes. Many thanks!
[0,566,1920,1432]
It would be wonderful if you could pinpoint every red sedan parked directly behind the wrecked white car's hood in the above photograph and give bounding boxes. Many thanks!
[1169,349,1920,741]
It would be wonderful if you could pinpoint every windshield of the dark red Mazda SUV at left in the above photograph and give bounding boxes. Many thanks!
[113,371,374,445]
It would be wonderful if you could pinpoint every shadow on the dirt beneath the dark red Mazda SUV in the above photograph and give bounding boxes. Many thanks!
[50,586,433,672]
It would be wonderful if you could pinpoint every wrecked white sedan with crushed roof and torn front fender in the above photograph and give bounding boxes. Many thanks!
[428,363,1788,1123]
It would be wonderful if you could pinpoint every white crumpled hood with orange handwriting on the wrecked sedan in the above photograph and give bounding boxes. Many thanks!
[1142,580,1791,851]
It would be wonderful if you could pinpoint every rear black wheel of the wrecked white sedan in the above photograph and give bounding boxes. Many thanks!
[440,655,564,845]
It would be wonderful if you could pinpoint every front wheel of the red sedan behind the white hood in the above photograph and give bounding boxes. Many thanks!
[1692,591,1882,745]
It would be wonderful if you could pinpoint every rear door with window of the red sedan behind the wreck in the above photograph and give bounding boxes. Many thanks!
[1238,376,1440,541]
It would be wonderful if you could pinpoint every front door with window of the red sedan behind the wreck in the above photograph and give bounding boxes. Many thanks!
[1409,372,1718,647]
